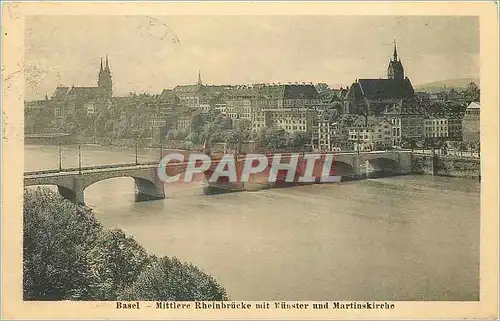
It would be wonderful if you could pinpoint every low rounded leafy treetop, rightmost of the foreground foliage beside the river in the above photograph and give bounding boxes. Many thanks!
[119,257,228,301]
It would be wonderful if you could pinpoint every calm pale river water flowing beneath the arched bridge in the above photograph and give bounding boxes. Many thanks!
[25,145,480,301]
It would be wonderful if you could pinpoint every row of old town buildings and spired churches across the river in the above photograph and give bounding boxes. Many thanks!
[27,45,480,151]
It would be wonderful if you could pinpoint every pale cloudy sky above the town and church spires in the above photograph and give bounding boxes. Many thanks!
[25,15,479,100]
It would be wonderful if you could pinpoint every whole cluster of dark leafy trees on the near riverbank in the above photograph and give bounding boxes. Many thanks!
[23,188,227,300]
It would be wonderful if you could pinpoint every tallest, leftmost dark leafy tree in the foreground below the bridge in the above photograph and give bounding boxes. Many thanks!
[23,188,102,300]
